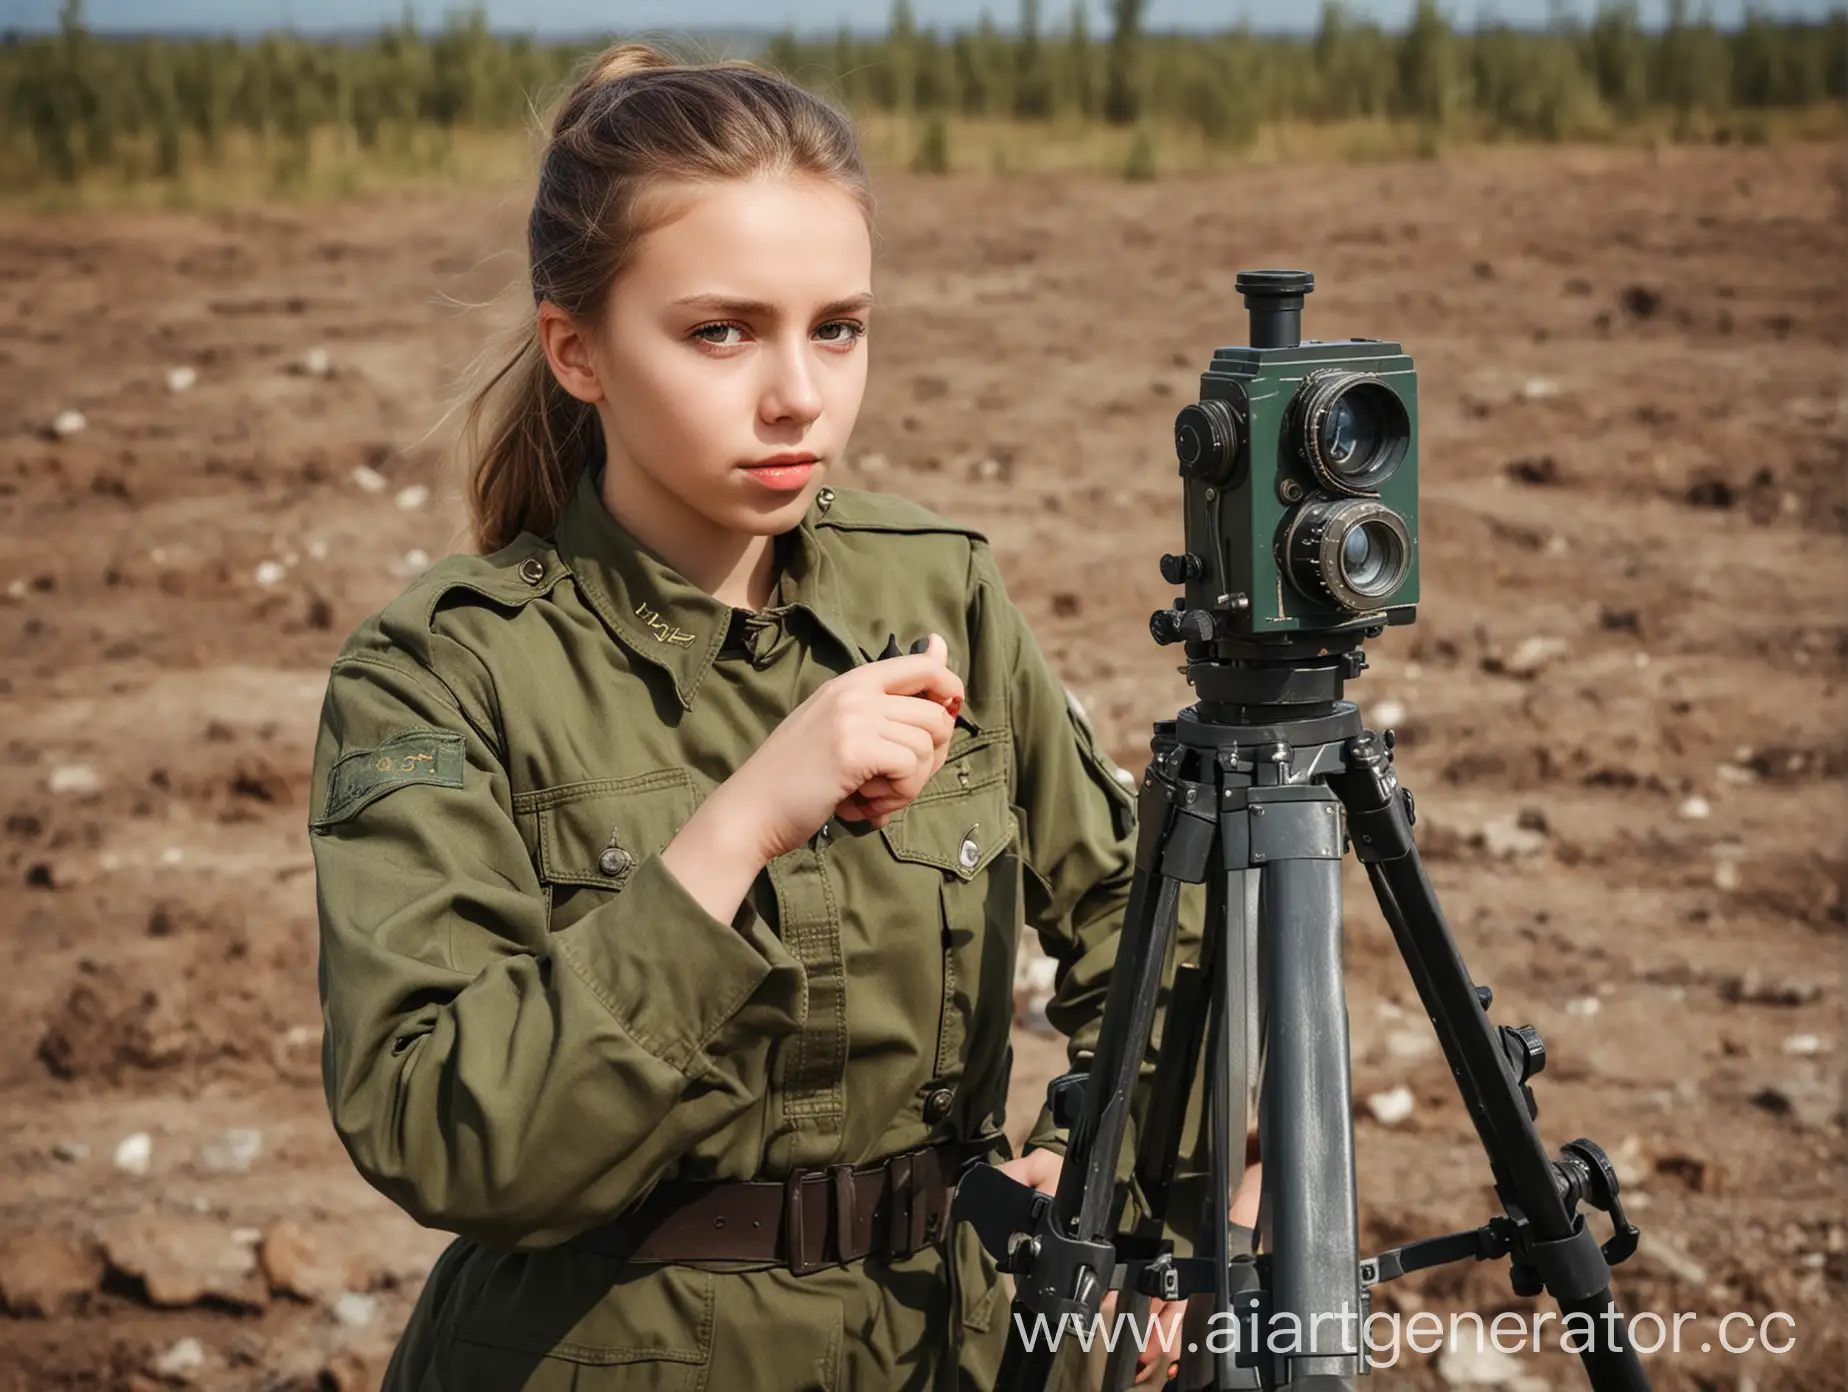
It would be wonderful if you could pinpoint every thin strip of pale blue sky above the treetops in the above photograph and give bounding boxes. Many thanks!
[0,0,1841,33]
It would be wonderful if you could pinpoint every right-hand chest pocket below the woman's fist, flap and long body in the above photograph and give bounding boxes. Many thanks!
[881,730,1020,1135]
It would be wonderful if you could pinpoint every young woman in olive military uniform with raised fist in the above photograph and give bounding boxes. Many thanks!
[310,44,1255,1392]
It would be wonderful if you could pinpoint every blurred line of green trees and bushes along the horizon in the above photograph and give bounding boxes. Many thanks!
[0,0,1848,189]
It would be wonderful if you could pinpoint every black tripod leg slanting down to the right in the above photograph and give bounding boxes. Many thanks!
[1329,736,1648,1392]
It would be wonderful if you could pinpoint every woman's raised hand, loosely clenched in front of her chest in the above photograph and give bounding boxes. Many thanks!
[726,634,963,861]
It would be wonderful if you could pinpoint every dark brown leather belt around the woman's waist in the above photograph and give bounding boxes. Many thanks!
[565,1135,1007,1276]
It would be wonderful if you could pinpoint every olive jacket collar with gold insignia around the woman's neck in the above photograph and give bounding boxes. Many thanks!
[554,464,870,710]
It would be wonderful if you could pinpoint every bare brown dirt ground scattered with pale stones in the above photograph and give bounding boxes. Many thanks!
[0,148,1848,1392]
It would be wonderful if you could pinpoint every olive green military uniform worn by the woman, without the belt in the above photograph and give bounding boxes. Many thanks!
[310,462,1197,1392]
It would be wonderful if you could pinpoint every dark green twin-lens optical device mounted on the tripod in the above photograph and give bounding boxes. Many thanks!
[1149,270,1417,725]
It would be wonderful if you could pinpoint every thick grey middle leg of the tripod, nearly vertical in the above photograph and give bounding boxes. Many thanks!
[1251,786,1364,1390]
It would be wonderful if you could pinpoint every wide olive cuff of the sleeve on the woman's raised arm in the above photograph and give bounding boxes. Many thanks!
[551,856,802,1078]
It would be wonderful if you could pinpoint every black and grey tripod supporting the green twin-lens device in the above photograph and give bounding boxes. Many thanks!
[952,632,1648,1392]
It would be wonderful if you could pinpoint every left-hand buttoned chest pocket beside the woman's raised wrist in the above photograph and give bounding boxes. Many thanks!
[514,769,695,932]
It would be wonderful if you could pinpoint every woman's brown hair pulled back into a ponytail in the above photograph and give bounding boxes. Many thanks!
[462,43,872,553]
